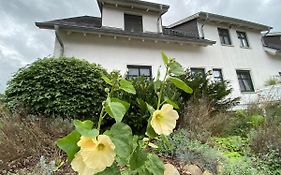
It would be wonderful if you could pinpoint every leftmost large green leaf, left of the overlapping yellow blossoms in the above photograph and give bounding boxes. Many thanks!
[56,130,80,161]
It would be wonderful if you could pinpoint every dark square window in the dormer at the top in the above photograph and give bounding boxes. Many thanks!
[124,14,142,33]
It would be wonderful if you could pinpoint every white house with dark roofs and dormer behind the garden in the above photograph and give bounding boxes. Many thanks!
[36,0,281,104]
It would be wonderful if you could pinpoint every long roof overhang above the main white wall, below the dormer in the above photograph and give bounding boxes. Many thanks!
[35,22,216,47]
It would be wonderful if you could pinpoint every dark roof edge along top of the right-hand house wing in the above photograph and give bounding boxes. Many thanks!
[168,12,272,31]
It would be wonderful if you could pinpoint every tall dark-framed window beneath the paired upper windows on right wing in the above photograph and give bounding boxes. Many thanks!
[236,70,254,92]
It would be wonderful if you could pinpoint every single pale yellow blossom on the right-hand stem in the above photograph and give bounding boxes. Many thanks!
[150,104,179,136]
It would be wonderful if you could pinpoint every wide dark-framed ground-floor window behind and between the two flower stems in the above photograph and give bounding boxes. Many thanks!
[127,65,152,78]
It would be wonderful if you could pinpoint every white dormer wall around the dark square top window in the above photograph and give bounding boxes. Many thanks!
[102,6,162,33]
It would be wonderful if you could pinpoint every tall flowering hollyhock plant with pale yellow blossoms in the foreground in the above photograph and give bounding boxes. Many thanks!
[56,52,192,175]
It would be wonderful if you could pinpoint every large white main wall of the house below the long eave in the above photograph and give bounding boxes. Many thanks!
[55,25,281,103]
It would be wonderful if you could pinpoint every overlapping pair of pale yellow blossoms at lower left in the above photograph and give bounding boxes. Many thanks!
[71,135,116,175]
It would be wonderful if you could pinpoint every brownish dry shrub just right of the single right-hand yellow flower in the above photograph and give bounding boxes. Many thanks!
[180,97,231,142]
